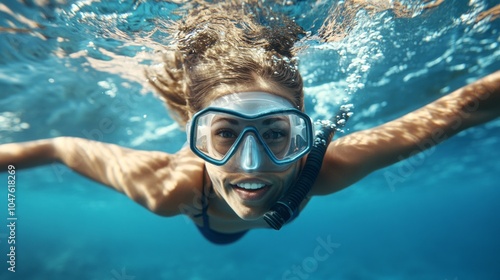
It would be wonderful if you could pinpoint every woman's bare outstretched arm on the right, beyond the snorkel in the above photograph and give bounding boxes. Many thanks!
[313,71,500,194]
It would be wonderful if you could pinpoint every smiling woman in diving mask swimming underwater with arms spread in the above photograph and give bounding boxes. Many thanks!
[0,3,500,244]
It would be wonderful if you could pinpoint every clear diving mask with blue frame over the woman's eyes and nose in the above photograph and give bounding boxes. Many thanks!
[186,92,313,172]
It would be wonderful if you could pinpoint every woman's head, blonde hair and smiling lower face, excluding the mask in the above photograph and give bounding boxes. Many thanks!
[147,4,304,219]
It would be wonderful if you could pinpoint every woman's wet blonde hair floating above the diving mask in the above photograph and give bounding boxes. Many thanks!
[146,3,304,126]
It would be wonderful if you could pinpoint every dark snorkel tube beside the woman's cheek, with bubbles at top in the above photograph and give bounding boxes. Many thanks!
[264,112,350,230]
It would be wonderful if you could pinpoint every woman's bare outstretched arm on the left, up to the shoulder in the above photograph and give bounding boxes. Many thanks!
[0,137,203,216]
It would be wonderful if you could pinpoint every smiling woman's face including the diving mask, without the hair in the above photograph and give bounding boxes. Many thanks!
[191,92,313,219]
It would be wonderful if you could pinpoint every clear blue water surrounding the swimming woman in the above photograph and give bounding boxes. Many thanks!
[0,0,500,280]
